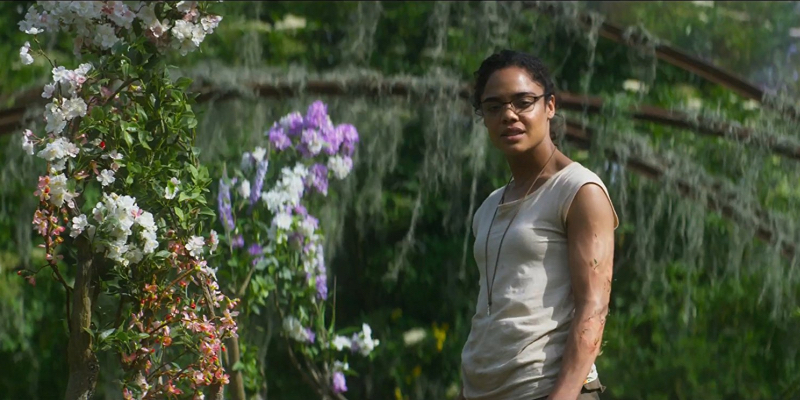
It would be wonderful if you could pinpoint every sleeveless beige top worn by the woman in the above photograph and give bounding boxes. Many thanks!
[461,162,618,400]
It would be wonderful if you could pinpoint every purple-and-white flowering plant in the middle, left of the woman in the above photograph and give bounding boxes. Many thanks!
[211,101,379,397]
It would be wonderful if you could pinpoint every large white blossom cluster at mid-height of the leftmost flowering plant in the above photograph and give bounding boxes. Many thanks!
[91,193,158,266]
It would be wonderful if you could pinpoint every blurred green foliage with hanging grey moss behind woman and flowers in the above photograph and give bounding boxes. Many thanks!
[0,1,800,400]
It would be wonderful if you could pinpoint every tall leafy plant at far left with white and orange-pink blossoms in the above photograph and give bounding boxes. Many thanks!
[19,1,238,399]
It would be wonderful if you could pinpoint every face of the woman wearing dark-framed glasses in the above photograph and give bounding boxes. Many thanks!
[481,67,555,155]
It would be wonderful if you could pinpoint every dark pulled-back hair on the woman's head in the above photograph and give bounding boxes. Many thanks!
[472,50,555,111]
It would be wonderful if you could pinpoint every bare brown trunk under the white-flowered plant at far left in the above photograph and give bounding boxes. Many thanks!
[64,237,99,400]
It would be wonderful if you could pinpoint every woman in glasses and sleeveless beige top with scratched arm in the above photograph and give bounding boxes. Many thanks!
[461,50,618,400]
